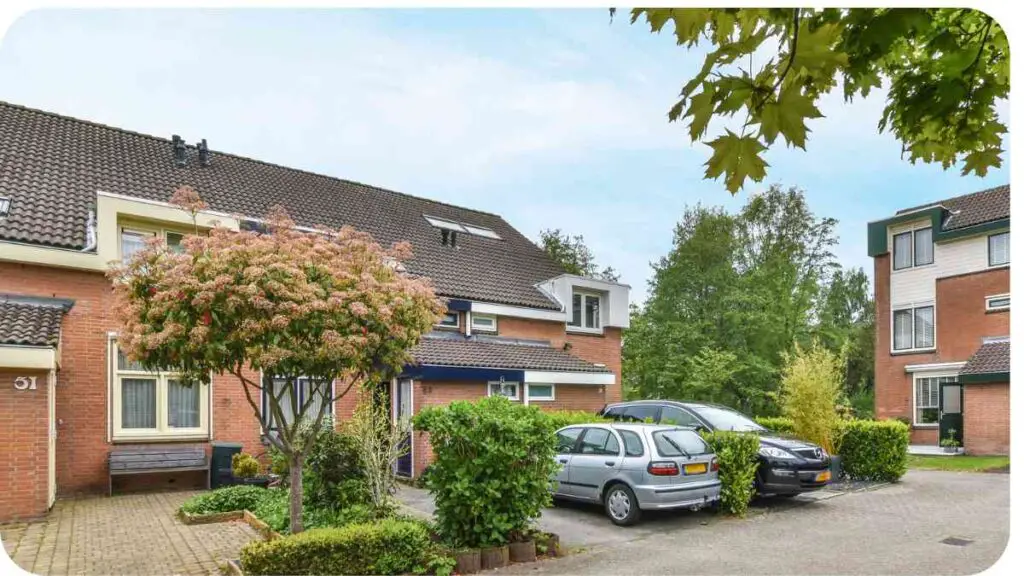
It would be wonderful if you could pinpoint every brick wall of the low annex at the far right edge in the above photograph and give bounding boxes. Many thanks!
[964,382,1010,454]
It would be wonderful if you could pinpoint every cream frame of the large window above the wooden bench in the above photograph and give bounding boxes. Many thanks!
[110,339,212,442]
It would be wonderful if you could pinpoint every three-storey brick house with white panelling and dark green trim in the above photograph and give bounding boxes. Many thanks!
[867,186,1010,454]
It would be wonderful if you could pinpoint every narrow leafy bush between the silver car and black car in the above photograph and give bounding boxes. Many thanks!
[700,430,761,516]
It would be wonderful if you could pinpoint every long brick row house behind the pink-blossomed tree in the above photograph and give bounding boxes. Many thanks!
[0,102,629,522]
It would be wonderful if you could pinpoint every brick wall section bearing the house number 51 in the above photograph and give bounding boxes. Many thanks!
[0,369,49,522]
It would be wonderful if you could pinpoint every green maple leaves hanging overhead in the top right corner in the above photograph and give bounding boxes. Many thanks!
[612,8,1010,194]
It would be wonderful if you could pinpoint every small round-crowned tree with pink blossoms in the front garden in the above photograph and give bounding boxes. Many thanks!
[111,187,443,533]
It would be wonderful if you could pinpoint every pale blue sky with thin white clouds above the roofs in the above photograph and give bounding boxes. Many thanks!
[0,9,1010,303]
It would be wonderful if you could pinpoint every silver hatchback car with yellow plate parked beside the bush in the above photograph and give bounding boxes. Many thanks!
[552,423,722,526]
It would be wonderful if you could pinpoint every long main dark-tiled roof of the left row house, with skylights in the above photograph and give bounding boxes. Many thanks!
[0,102,564,310]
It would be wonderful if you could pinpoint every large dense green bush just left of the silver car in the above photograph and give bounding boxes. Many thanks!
[414,397,556,546]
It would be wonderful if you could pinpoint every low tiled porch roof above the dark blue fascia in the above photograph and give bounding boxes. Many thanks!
[413,335,609,373]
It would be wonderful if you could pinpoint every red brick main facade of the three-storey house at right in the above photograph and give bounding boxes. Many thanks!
[874,254,1010,444]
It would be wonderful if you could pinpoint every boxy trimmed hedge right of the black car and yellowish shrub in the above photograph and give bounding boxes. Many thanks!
[837,420,910,482]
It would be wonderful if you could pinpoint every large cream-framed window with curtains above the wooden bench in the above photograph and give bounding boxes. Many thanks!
[112,344,210,440]
